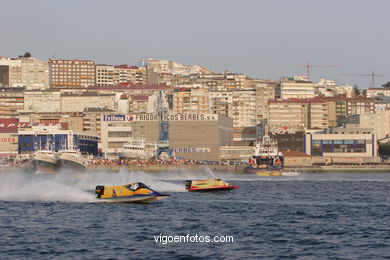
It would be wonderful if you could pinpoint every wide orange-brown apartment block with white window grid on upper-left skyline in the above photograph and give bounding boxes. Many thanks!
[49,59,96,89]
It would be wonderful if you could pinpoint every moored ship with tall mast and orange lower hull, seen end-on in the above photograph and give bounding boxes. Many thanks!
[244,127,284,176]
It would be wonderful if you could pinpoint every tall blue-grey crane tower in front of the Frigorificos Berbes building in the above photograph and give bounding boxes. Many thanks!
[156,91,172,159]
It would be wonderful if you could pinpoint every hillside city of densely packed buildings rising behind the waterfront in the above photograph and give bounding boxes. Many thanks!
[0,53,390,166]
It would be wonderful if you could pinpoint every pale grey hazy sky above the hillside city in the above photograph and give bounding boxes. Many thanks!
[0,0,390,88]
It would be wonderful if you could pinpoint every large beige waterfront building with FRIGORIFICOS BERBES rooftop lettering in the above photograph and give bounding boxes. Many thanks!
[101,114,233,160]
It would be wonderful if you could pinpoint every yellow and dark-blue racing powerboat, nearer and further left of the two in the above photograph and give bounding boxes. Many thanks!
[95,182,169,203]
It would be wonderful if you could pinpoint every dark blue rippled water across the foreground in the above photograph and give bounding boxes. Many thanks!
[0,173,390,259]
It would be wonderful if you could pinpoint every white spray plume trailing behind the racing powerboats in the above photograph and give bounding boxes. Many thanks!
[0,171,186,203]
